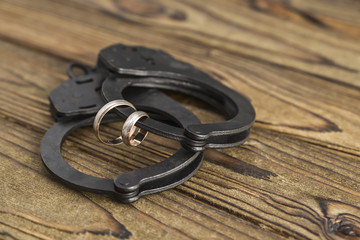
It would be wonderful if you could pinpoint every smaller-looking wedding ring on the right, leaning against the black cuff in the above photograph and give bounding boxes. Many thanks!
[122,111,149,147]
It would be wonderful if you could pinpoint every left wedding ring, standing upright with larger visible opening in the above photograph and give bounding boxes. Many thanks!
[93,100,136,146]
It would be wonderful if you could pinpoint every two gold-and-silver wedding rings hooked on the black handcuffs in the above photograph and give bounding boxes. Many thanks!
[93,100,149,147]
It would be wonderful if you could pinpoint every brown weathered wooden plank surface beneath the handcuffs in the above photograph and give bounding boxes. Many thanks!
[0,0,360,239]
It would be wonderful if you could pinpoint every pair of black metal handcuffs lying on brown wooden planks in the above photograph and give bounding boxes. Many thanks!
[41,44,255,203]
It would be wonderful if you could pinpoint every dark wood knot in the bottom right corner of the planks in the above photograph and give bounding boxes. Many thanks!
[320,199,360,239]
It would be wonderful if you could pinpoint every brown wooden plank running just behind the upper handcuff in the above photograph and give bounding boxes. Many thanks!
[0,1,360,154]
